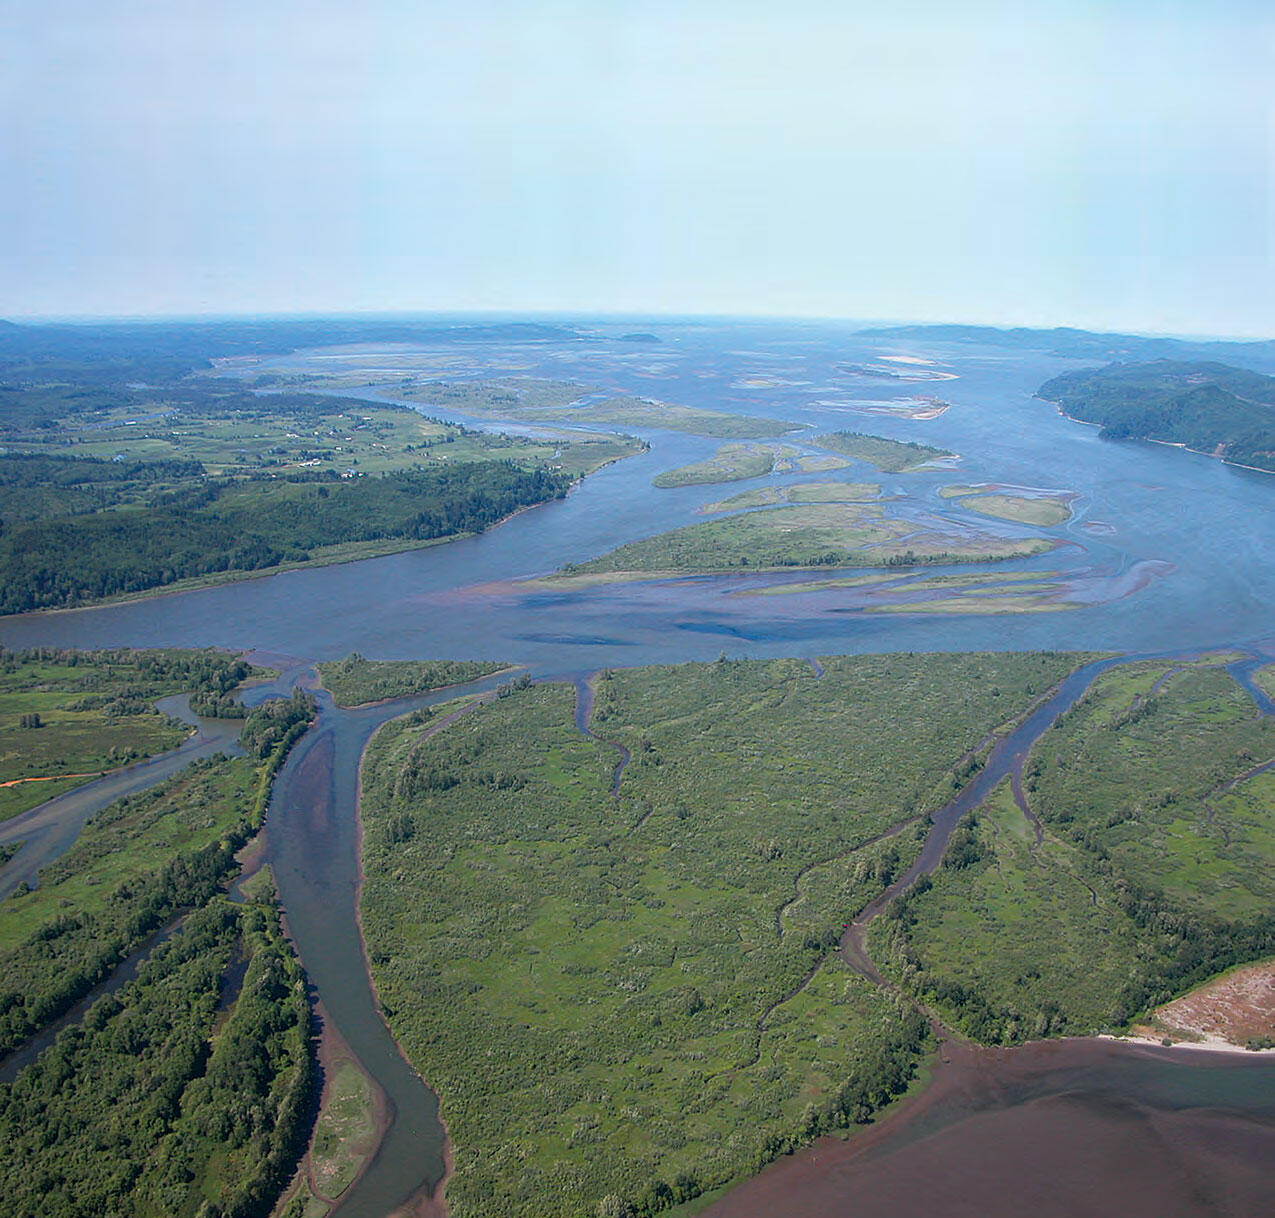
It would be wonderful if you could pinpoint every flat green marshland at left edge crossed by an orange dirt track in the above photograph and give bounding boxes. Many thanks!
[0,648,254,819]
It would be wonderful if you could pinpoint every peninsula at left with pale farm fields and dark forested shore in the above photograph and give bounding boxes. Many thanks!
[0,381,644,613]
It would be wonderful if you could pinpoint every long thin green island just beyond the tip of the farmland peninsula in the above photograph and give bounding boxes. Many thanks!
[394,376,801,440]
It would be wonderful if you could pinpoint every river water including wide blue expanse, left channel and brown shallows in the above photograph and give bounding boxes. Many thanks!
[0,320,1275,1218]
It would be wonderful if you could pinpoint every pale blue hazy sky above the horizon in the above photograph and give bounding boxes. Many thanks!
[0,0,1275,337]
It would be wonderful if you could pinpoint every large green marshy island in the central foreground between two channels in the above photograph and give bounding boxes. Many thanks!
[362,654,1077,1218]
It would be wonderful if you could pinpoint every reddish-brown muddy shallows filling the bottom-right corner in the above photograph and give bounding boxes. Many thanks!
[704,1039,1275,1218]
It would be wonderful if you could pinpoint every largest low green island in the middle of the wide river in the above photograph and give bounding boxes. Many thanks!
[562,504,1054,575]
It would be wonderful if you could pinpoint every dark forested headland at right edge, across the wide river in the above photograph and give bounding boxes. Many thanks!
[1038,360,1275,471]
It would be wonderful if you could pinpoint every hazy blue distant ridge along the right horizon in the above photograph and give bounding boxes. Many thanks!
[858,325,1275,371]
